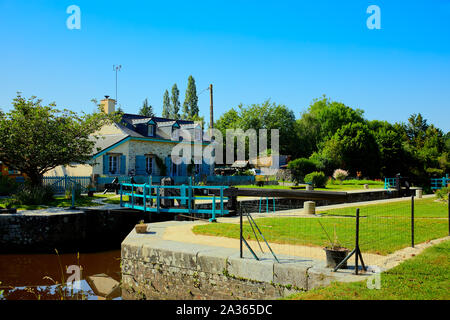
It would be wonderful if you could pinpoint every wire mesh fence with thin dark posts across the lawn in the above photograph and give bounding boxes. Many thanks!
[240,197,449,268]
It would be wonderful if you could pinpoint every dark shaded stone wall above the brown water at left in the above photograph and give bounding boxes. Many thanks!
[0,209,148,253]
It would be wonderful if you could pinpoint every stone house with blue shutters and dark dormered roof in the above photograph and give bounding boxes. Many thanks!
[46,97,214,177]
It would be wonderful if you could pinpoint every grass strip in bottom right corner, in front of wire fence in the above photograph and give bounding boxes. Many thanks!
[287,241,450,300]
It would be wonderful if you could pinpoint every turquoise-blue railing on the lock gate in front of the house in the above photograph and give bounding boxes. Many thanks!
[120,183,229,222]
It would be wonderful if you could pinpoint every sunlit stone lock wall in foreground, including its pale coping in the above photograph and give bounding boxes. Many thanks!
[121,223,363,300]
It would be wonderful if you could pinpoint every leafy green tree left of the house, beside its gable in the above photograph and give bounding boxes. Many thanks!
[0,93,117,185]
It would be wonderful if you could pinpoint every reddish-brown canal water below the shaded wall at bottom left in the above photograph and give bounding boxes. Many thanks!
[0,250,121,300]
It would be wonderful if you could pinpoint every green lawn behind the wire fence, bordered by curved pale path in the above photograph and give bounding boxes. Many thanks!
[193,199,448,255]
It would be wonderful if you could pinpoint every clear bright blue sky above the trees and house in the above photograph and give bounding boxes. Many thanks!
[0,0,450,131]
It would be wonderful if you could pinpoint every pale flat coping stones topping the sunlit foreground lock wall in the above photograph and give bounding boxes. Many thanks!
[121,221,371,290]
